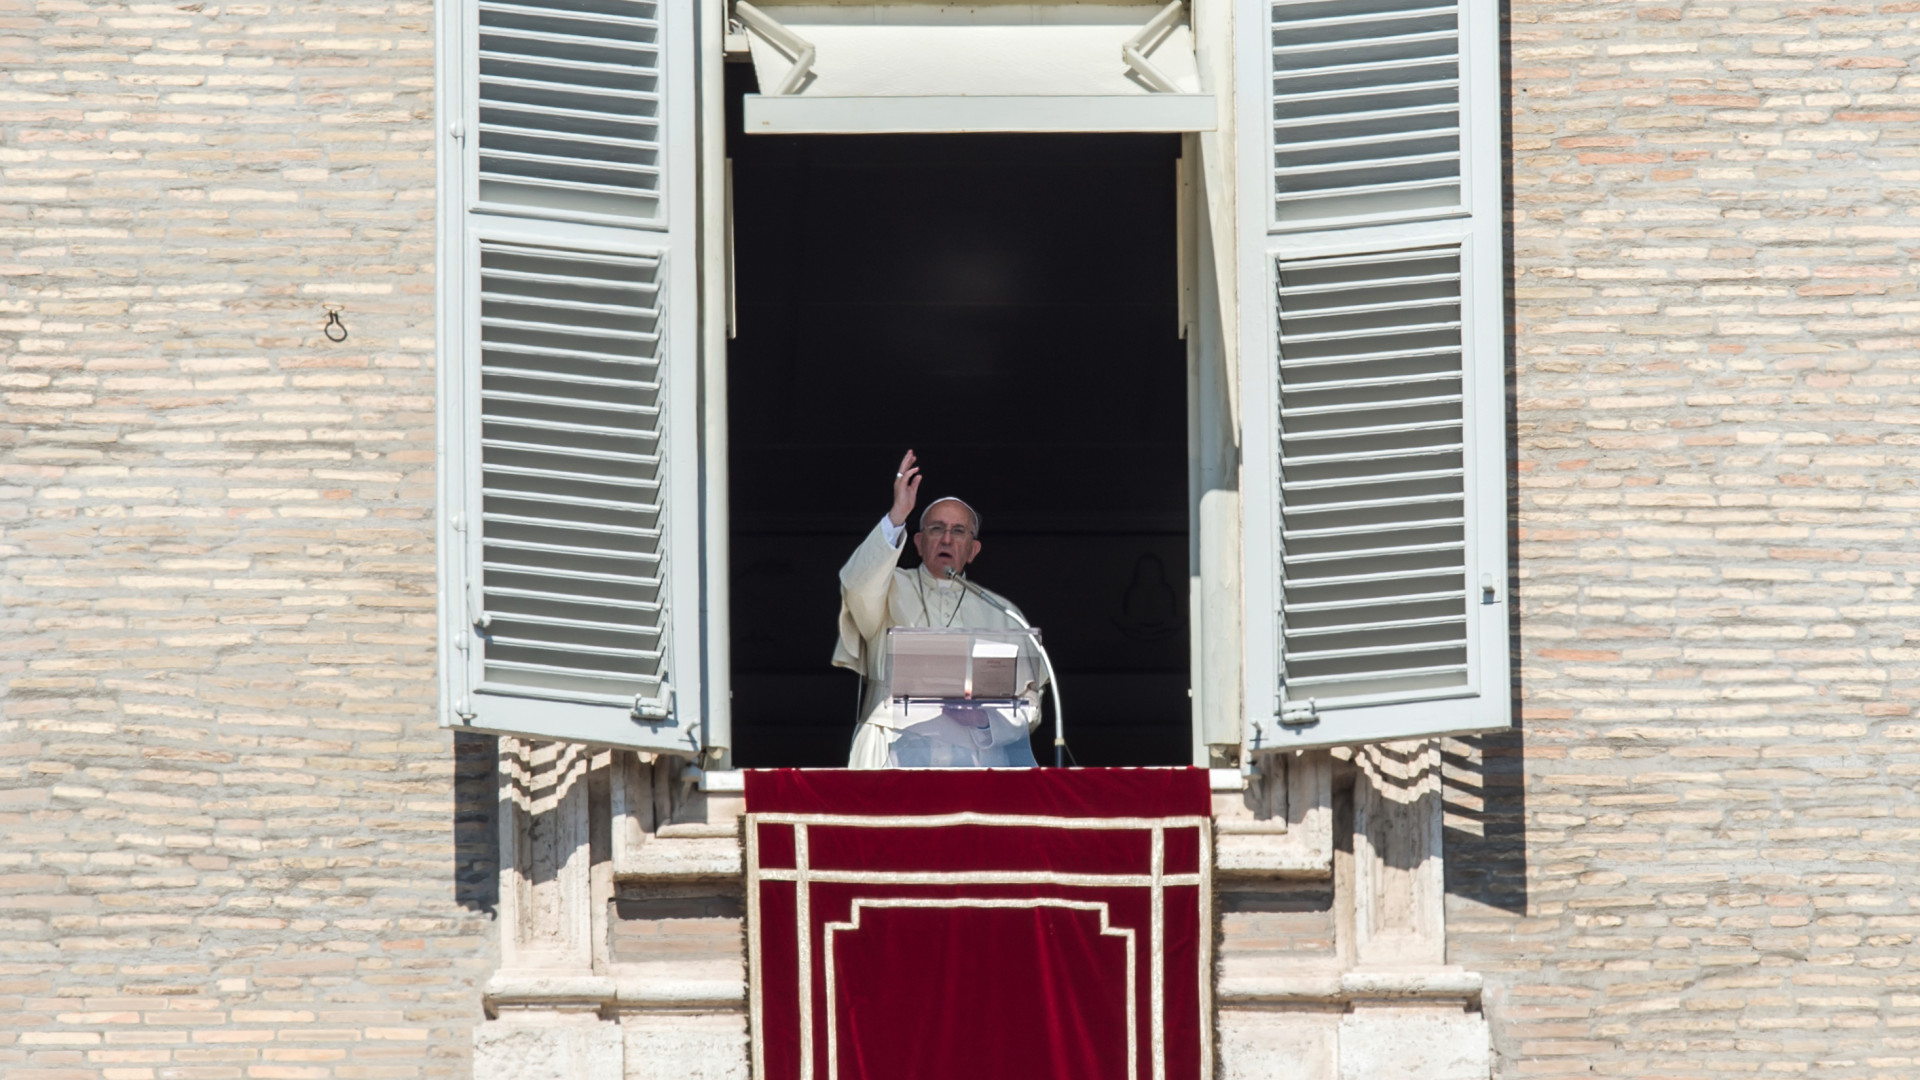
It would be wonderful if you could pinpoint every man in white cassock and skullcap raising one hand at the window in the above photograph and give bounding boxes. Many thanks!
[833,450,1044,769]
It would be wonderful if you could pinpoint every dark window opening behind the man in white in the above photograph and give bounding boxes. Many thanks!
[728,67,1192,767]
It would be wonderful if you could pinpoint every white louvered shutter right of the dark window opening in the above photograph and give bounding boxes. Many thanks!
[1236,0,1509,751]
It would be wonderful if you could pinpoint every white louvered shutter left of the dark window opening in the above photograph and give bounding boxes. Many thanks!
[440,0,701,753]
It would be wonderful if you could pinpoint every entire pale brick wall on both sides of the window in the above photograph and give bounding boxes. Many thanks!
[0,0,1920,1080]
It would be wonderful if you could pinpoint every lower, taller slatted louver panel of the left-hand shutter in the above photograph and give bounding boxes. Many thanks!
[480,242,668,707]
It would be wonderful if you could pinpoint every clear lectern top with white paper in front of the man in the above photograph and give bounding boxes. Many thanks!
[887,626,1041,701]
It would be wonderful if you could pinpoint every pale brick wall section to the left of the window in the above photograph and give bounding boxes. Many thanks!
[0,0,495,1080]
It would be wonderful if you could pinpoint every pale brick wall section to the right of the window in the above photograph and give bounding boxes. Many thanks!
[1450,0,1920,1078]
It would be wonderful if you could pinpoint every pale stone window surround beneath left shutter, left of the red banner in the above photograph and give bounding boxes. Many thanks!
[474,738,747,1080]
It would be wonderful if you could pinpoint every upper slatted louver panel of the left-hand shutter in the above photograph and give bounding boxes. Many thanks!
[476,0,662,221]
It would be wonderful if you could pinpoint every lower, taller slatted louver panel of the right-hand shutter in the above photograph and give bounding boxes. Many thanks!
[1279,248,1469,703]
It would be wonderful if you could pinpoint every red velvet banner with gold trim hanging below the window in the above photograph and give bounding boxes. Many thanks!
[747,769,1213,1080]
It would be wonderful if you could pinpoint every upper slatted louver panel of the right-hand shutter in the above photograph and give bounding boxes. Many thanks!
[1271,0,1461,227]
